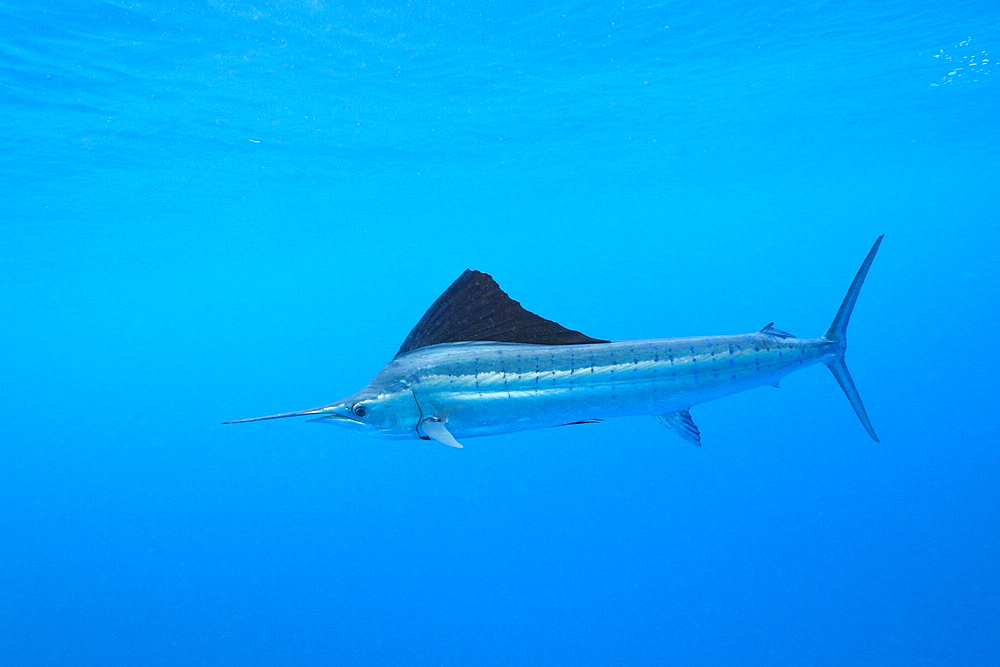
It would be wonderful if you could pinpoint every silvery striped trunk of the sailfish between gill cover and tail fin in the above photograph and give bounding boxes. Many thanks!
[386,333,831,437]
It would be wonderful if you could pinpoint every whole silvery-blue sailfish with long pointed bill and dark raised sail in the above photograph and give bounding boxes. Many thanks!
[224,236,882,448]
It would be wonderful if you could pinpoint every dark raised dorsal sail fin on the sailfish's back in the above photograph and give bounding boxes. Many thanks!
[396,269,610,357]
